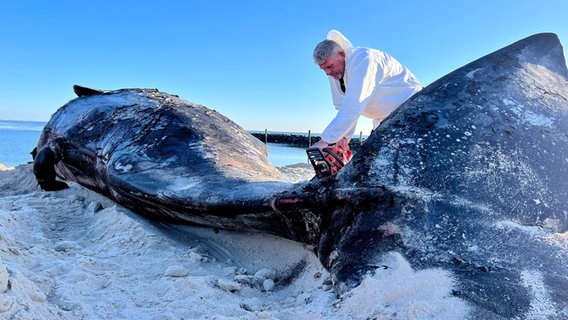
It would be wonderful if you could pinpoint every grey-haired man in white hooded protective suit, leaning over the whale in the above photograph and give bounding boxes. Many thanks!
[312,30,422,150]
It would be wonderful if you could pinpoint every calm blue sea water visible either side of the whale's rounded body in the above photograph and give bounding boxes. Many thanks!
[0,120,308,167]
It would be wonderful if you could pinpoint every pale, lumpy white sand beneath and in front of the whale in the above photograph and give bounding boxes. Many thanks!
[0,164,468,320]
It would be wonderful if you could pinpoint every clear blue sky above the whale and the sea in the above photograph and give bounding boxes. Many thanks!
[0,0,568,134]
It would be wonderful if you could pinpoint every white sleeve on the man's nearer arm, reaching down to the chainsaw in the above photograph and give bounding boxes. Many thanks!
[322,50,383,143]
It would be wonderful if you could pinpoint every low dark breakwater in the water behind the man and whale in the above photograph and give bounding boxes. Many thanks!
[251,130,366,150]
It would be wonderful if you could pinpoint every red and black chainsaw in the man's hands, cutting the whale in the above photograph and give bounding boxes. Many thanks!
[306,144,353,179]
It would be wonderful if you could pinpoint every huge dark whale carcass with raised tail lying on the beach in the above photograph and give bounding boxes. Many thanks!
[34,34,568,319]
